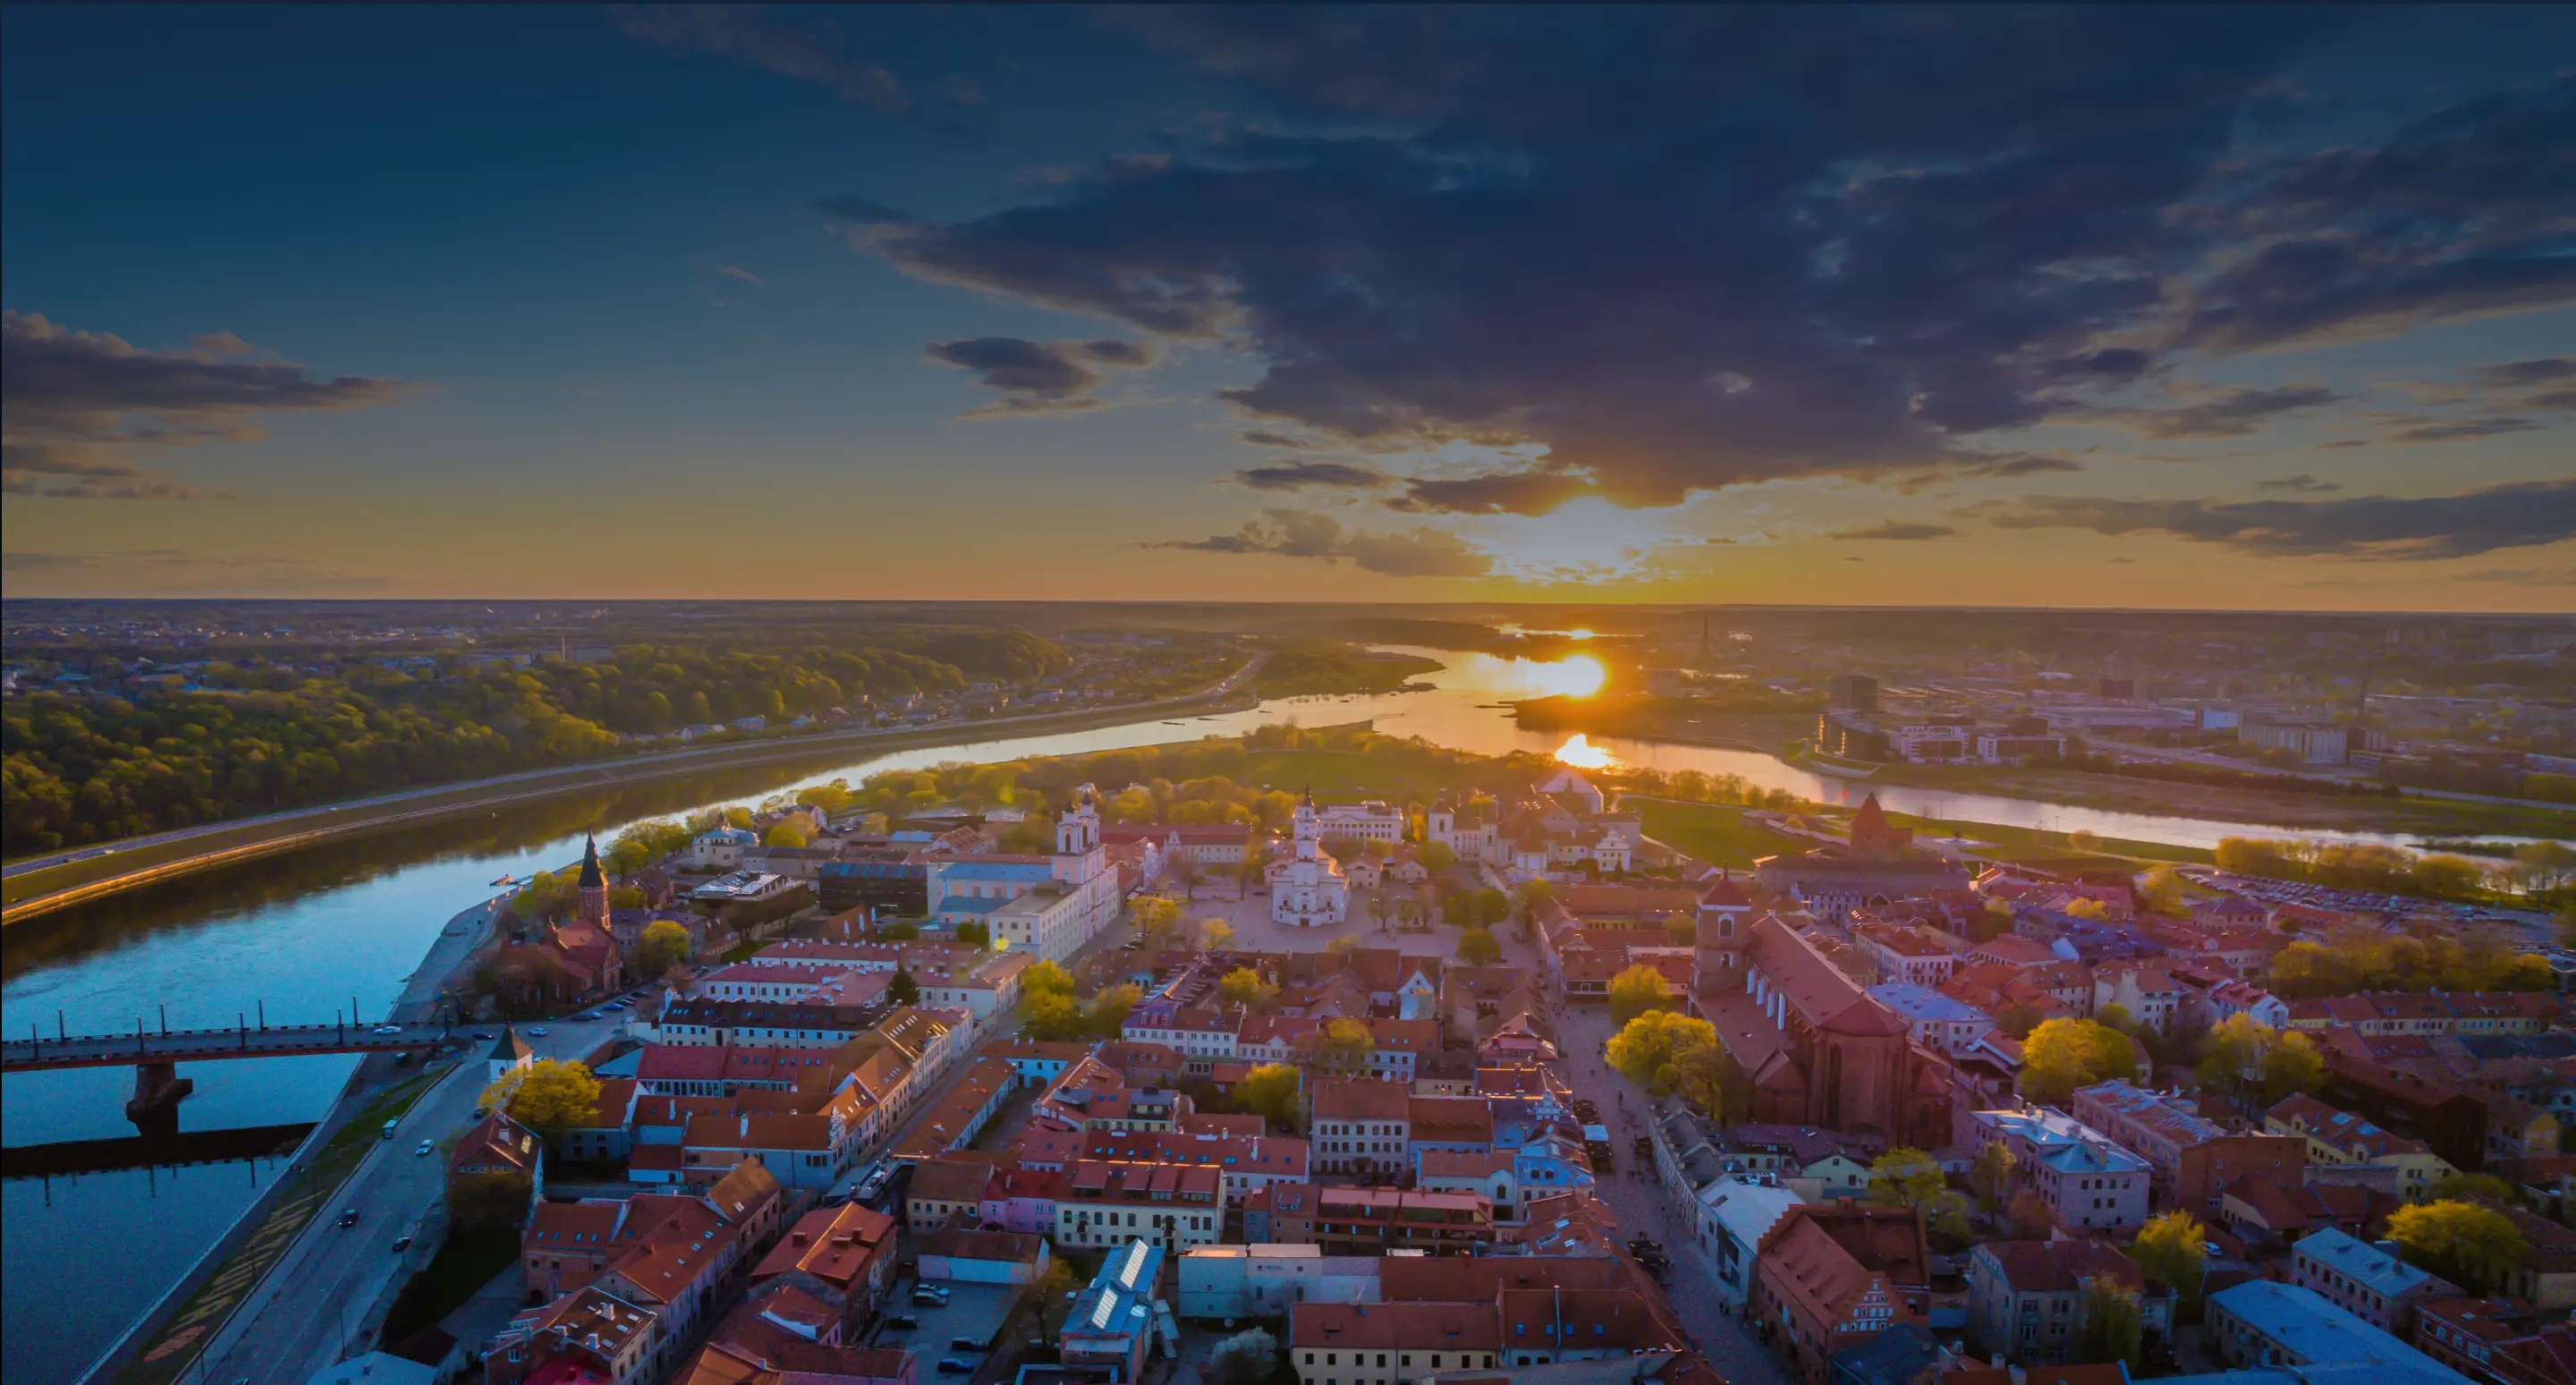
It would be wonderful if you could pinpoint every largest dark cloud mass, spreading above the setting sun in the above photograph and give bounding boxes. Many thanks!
[814,8,2576,513]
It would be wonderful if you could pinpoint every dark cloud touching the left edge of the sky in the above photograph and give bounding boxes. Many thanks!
[0,311,419,499]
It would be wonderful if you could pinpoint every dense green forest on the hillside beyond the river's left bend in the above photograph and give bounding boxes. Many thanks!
[0,628,1072,857]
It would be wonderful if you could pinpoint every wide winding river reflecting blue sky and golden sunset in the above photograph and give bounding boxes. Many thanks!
[0,649,2534,1380]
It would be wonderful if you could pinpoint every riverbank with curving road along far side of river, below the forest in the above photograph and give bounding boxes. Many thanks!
[0,659,1259,924]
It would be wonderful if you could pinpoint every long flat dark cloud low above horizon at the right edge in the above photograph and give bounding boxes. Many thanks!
[1963,481,2576,558]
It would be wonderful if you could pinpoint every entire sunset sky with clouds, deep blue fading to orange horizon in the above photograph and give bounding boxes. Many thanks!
[0,5,2576,610]
